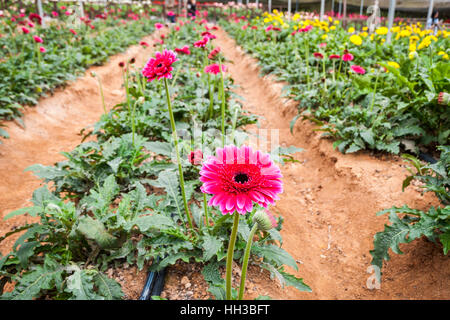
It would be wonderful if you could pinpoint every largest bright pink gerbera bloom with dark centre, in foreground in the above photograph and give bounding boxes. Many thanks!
[200,146,283,214]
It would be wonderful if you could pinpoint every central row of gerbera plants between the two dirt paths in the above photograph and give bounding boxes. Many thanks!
[0,14,310,299]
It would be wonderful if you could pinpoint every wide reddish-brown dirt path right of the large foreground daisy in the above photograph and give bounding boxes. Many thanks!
[211,30,450,299]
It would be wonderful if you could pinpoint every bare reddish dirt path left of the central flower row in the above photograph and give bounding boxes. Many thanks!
[0,31,161,254]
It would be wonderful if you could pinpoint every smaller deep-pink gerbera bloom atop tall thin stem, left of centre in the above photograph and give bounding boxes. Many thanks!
[142,49,178,82]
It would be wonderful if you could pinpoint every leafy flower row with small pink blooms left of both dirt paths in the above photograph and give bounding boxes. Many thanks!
[0,6,162,137]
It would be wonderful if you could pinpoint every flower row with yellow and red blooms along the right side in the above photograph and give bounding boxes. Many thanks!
[221,10,450,276]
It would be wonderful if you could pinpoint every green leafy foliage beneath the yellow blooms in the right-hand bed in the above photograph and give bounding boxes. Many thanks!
[220,18,450,154]
